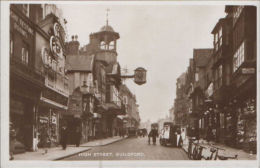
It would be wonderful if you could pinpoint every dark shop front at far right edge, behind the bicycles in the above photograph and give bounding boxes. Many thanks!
[233,68,257,153]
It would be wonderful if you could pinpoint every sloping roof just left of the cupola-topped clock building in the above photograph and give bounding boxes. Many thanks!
[66,55,94,71]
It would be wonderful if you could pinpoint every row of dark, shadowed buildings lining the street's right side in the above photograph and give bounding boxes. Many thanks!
[175,6,257,153]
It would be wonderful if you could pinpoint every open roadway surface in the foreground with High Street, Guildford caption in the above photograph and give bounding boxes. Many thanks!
[64,137,188,161]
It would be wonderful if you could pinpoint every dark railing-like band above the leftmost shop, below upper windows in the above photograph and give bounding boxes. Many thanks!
[10,56,44,85]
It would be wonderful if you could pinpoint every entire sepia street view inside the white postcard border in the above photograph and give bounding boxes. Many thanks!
[5,3,257,162]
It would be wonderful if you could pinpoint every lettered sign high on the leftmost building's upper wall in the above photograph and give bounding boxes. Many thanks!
[10,11,33,38]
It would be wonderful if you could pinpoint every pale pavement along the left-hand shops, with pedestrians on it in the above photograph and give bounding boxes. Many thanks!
[14,136,124,160]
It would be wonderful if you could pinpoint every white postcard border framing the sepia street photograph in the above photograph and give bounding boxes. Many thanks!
[0,1,260,168]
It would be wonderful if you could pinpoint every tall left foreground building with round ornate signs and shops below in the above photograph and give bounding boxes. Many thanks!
[10,4,68,150]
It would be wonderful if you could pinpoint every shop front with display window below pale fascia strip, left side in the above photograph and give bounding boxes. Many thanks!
[35,87,68,148]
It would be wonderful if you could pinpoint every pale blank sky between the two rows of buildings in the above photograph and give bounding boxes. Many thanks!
[58,3,226,122]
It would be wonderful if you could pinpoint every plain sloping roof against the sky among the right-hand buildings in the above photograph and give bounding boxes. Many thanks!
[193,48,213,67]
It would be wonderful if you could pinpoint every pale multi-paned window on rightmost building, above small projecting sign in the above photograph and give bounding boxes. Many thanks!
[233,42,245,72]
